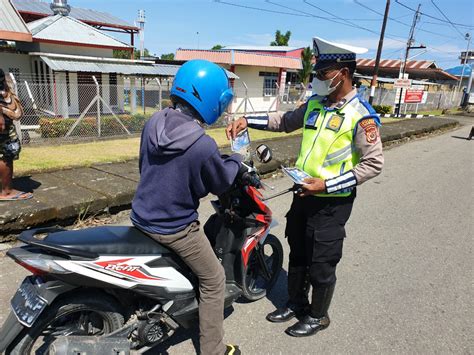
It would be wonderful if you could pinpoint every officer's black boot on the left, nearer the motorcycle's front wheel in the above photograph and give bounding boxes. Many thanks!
[266,267,309,323]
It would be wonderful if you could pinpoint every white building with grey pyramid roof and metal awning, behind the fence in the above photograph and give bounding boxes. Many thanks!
[0,0,181,127]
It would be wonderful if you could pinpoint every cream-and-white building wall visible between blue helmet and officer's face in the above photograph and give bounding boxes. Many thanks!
[232,66,279,113]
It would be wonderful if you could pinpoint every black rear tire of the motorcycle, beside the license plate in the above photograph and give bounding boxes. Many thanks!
[6,293,124,355]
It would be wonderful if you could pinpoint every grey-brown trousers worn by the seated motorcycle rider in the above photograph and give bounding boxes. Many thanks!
[145,221,226,355]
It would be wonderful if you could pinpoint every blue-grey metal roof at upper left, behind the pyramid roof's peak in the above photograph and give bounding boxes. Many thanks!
[13,0,138,30]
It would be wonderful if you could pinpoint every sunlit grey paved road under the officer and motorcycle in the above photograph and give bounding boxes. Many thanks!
[0,121,474,354]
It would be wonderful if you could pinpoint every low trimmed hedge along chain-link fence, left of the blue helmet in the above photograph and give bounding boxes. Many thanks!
[39,114,151,138]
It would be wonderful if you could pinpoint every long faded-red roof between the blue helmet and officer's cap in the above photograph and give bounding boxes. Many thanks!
[176,49,301,69]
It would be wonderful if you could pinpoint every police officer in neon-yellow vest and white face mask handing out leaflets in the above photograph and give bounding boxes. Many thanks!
[227,37,383,337]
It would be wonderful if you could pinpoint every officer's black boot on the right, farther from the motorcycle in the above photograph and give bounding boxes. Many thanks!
[285,283,336,337]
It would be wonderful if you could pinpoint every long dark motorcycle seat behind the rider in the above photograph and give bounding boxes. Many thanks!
[18,226,170,258]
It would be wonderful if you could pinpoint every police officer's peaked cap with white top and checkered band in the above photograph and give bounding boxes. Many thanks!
[313,37,368,70]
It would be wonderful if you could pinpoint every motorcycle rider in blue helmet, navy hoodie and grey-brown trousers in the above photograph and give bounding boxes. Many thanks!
[130,60,241,355]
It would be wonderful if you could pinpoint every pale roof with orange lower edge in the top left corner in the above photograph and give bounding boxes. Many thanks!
[0,0,32,42]
